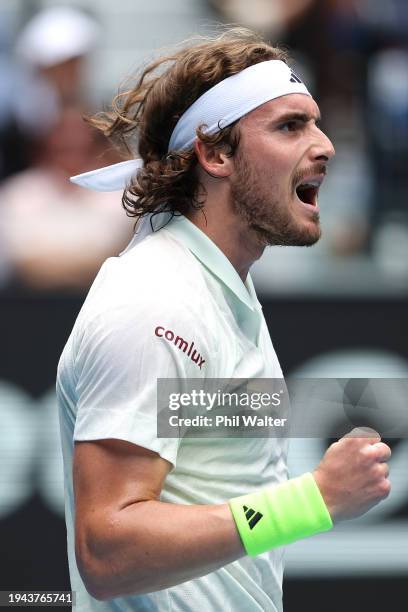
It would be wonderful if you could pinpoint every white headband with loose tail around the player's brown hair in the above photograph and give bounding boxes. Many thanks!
[70,60,310,191]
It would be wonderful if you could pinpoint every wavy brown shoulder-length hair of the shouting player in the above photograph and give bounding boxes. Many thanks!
[88,27,288,218]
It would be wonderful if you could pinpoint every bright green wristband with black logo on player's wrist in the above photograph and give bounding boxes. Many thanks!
[229,472,333,557]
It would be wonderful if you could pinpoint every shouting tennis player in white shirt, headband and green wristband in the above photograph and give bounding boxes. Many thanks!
[57,29,390,612]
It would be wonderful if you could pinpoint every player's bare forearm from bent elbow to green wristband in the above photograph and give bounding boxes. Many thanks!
[77,500,245,599]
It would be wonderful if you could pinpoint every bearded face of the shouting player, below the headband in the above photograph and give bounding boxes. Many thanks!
[230,94,334,246]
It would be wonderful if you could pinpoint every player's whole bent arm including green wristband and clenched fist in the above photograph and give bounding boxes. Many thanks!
[74,432,391,599]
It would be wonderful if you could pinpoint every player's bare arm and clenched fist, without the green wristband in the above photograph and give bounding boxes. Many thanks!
[74,430,391,599]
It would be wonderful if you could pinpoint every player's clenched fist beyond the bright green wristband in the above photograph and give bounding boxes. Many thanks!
[313,428,391,523]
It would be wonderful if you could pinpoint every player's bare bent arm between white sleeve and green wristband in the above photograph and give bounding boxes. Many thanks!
[74,440,245,599]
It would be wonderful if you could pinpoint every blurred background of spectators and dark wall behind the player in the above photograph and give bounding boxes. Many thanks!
[0,0,408,612]
